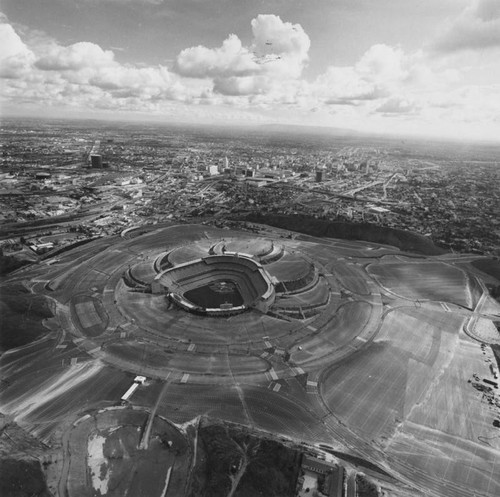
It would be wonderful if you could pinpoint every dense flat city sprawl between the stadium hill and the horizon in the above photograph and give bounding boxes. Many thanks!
[0,116,500,272]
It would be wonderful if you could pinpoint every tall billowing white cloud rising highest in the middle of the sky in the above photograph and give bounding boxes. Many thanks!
[174,15,311,95]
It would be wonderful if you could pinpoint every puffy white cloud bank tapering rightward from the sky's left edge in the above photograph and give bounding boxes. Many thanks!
[0,18,200,113]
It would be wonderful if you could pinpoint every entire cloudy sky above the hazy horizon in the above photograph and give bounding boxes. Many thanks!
[0,0,500,140]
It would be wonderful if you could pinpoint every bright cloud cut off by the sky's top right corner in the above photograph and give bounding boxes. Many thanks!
[431,0,500,53]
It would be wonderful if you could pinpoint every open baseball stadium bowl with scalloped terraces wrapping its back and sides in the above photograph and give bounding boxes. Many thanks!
[123,238,332,320]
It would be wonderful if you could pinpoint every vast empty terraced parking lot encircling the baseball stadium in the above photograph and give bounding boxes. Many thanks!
[0,225,500,497]
